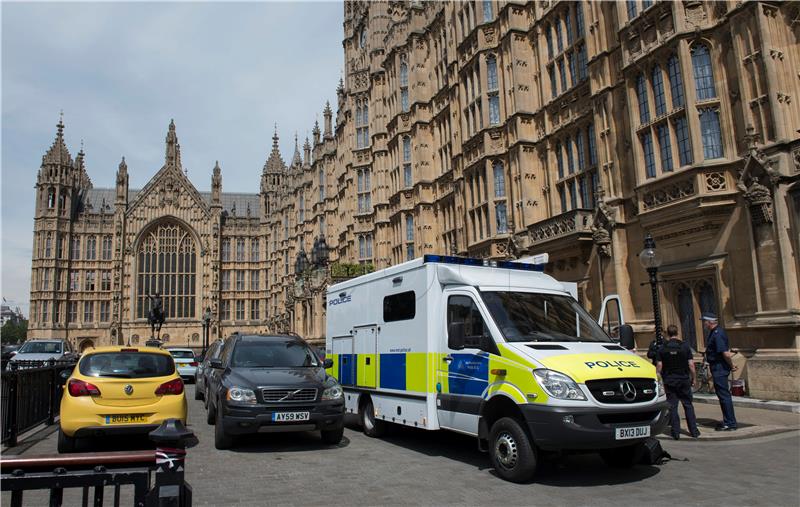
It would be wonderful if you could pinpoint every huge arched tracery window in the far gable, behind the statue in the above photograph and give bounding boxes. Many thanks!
[136,222,197,319]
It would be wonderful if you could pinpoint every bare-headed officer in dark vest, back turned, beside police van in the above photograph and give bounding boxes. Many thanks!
[656,325,700,440]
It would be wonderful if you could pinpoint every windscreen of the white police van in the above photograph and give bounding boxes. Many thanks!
[481,291,611,342]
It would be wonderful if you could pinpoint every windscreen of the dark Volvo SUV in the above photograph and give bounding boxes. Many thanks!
[231,340,319,368]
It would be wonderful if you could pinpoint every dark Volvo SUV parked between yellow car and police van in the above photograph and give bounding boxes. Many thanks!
[205,334,344,449]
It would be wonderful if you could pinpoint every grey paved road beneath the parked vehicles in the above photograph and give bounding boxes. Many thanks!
[2,386,800,507]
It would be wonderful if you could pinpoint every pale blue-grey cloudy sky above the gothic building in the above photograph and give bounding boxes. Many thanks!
[0,1,343,316]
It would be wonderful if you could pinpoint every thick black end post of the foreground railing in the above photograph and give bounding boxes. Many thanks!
[147,419,197,507]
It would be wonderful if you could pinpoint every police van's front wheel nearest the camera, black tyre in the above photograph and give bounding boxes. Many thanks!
[489,417,536,482]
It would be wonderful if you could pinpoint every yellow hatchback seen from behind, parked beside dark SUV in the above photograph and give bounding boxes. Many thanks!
[58,347,186,453]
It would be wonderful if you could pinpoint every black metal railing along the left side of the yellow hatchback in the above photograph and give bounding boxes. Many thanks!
[0,360,75,447]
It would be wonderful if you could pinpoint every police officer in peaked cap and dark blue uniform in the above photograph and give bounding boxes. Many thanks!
[701,313,736,431]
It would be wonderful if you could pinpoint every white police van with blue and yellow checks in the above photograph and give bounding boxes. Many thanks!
[326,255,667,482]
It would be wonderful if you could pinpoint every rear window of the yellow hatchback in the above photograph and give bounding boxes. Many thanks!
[79,352,175,378]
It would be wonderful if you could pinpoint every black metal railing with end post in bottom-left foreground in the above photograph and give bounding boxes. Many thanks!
[0,419,197,507]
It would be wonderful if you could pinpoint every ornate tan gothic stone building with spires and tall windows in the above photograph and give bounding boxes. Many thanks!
[32,0,800,400]
